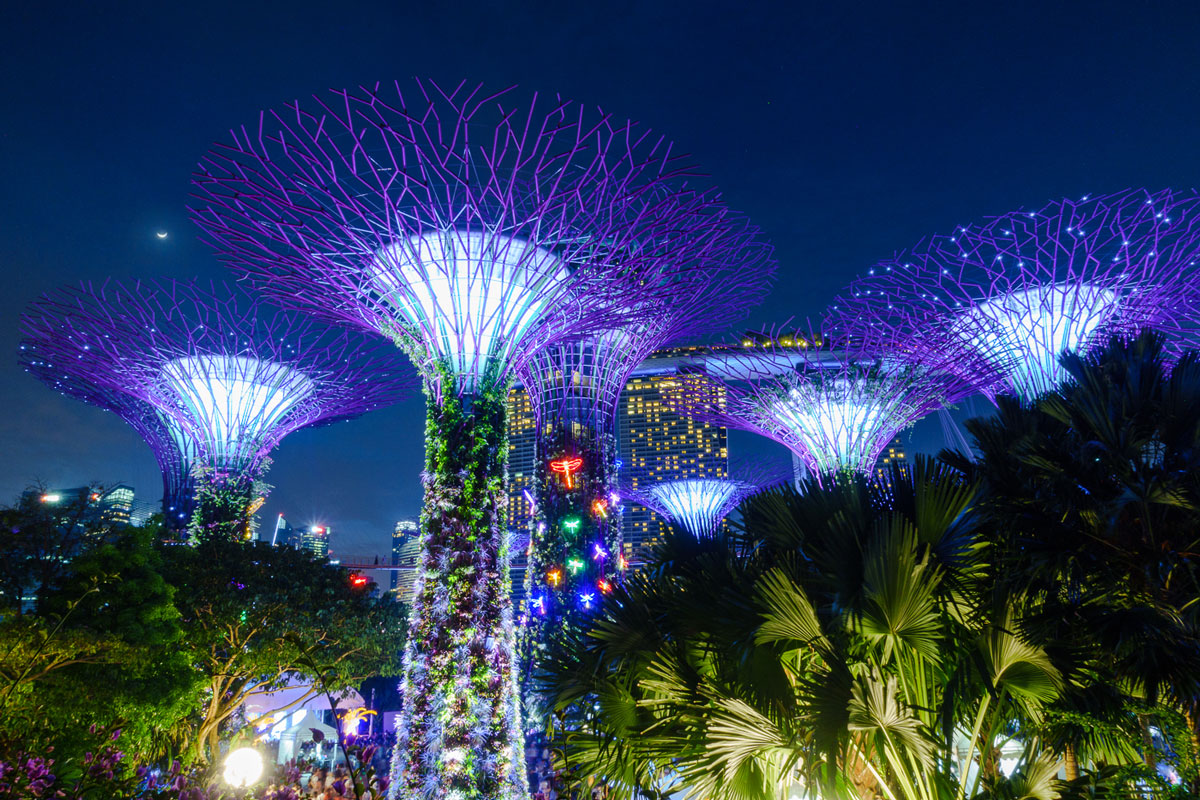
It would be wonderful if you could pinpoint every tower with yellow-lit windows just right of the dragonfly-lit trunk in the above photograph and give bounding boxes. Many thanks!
[618,371,730,560]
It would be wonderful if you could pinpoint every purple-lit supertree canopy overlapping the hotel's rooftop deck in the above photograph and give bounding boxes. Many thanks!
[668,325,994,481]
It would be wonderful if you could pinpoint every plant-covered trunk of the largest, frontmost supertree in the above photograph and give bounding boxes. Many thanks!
[392,383,528,800]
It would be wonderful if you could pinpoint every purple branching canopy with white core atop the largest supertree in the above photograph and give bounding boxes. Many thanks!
[194,82,726,393]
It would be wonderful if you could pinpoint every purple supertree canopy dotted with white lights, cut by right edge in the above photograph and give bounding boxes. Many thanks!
[835,190,1200,402]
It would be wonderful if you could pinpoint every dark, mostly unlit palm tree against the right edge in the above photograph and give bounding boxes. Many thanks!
[943,333,1200,790]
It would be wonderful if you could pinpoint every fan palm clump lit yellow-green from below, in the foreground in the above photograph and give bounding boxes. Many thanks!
[545,459,1061,800]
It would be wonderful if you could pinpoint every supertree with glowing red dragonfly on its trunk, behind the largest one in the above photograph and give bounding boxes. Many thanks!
[516,206,774,628]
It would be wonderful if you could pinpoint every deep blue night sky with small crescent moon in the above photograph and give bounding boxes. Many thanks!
[0,0,1200,563]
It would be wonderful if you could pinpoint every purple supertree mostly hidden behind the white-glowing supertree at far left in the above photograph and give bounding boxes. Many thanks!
[19,362,197,530]
